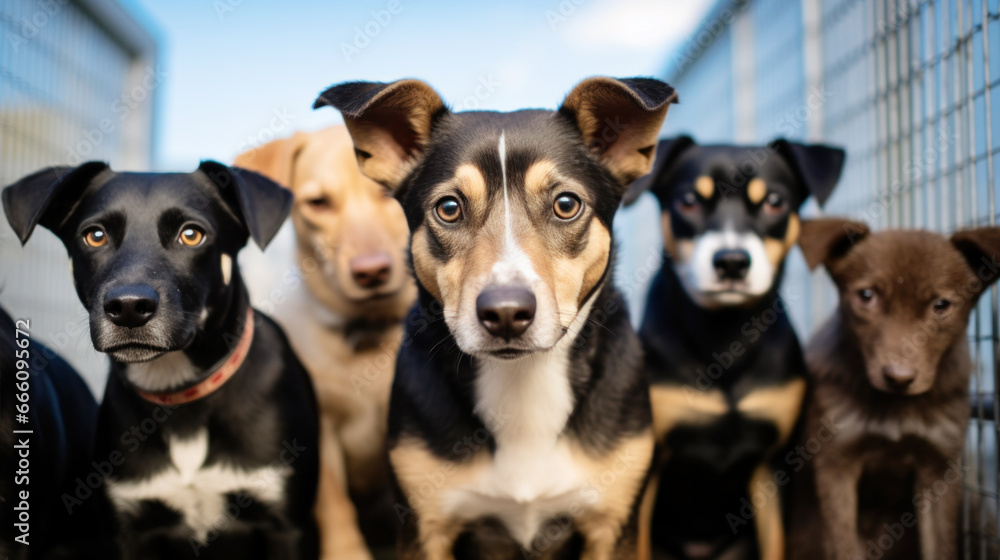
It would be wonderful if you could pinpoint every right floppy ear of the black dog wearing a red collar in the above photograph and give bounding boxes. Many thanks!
[198,160,292,249]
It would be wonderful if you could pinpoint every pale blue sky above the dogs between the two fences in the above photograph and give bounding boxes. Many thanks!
[125,0,712,171]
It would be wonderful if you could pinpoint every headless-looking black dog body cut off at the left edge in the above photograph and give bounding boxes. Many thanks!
[0,309,107,559]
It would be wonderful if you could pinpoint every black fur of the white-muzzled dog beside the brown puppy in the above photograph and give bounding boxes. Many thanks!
[626,136,844,558]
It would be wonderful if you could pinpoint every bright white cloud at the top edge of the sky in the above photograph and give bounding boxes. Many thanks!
[546,0,713,51]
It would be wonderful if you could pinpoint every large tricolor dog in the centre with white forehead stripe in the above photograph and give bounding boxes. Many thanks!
[316,78,676,560]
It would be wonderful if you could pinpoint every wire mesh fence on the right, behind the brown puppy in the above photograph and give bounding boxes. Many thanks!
[626,0,1000,557]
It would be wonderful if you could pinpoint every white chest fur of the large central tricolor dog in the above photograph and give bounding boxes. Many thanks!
[444,342,593,548]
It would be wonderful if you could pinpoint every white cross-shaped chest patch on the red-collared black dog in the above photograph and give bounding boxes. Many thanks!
[108,429,290,543]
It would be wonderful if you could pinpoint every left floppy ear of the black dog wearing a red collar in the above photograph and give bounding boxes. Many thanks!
[3,161,108,245]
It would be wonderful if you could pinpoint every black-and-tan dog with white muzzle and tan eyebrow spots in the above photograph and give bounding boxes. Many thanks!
[626,137,844,560]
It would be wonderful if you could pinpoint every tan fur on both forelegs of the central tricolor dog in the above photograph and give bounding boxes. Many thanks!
[389,433,653,560]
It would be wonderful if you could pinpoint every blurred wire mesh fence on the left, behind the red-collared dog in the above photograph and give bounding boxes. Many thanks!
[0,0,157,394]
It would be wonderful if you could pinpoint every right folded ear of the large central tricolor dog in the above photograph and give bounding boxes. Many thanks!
[559,77,677,188]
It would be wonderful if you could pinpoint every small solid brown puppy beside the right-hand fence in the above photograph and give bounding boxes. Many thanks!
[790,219,1000,560]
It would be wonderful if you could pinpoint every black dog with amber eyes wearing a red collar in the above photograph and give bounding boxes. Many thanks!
[3,161,318,559]
